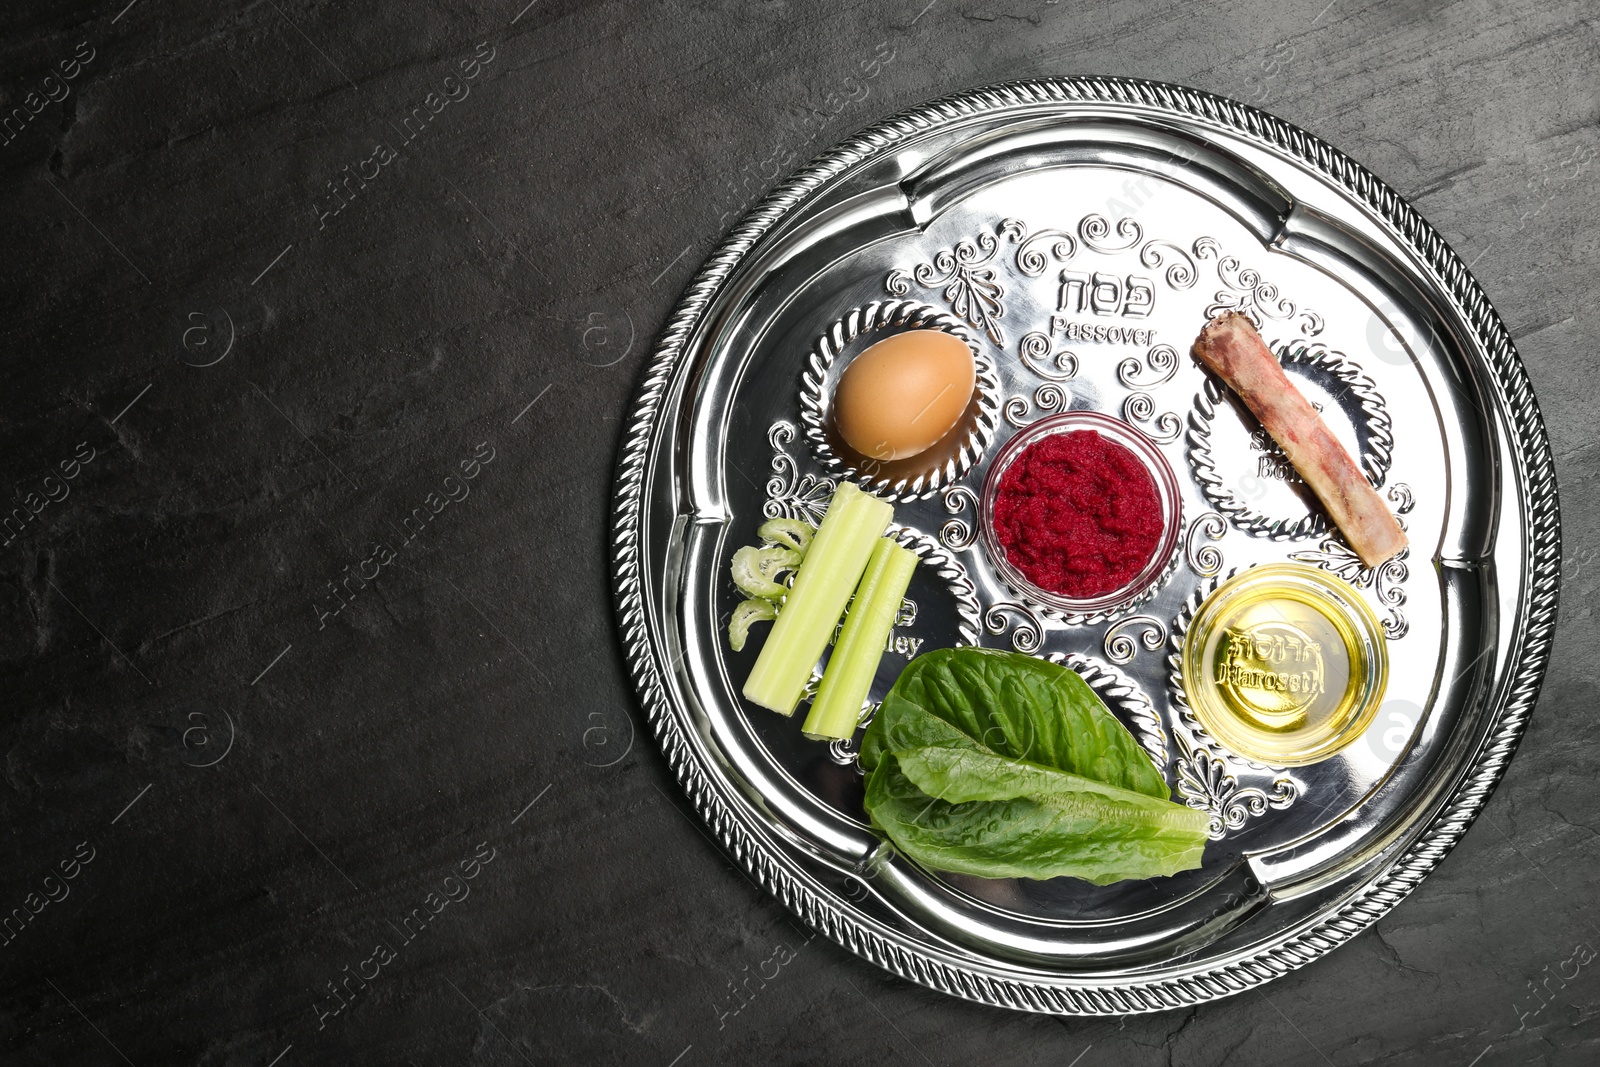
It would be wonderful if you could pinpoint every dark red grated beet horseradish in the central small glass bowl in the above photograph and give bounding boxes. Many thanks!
[994,430,1163,600]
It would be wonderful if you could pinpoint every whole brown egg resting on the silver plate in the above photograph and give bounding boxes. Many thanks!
[834,330,978,461]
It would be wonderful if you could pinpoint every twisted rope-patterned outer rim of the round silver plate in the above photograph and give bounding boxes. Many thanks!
[611,77,1560,1014]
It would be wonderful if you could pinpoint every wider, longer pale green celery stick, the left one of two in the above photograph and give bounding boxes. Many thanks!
[744,482,894,715]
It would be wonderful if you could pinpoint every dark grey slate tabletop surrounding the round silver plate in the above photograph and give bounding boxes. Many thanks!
[0,0,1600,1067]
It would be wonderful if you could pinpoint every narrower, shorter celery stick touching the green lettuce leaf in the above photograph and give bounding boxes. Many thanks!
[800,537,917,741]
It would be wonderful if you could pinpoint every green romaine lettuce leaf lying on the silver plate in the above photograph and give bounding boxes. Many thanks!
[861,648,1208,885]
